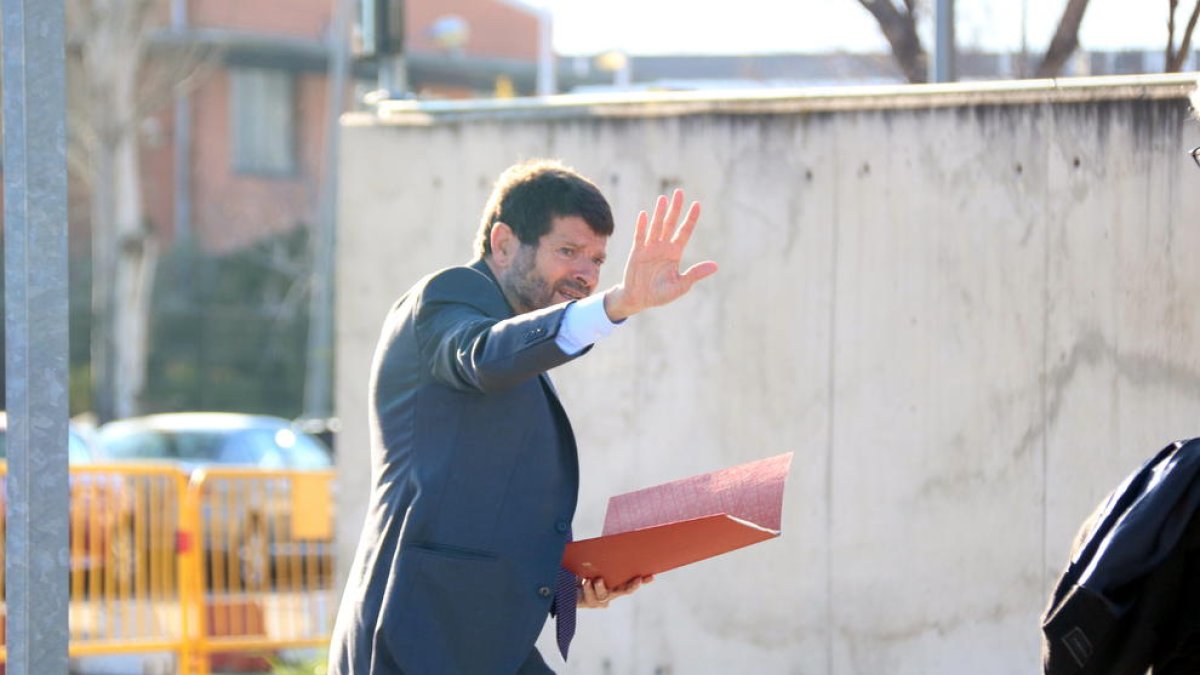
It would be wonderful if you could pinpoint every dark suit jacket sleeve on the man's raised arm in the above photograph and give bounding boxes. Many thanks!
[415,268,587,394]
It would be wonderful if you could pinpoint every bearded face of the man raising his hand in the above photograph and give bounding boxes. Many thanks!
[497,216,608,313]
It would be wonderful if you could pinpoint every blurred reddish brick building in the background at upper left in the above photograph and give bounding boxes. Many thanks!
[140,0,539,252]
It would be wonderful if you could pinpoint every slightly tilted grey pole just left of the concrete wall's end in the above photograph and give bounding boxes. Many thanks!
[305,0,354,419]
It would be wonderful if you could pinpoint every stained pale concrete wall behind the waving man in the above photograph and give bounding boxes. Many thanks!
[337,78,1200,675]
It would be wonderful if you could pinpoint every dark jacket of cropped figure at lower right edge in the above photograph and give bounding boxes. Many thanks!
[1042,440,1200,675]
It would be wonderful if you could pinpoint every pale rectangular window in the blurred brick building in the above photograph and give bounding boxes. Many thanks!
[230,67,296,175]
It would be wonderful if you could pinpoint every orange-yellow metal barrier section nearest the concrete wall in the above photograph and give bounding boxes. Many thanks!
[188,468,336,673]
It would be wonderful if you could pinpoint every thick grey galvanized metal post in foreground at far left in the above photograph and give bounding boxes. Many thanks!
[0,0,70,675]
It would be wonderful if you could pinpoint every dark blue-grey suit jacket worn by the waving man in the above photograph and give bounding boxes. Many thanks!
[330,261,588,675]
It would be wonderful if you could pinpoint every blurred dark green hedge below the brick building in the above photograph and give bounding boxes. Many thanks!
[48,227,308,418]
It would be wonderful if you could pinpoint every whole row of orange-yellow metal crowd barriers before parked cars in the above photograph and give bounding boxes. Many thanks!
[0,464,335,675]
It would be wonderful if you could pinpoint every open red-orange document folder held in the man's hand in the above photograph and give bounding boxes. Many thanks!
[563,453,792,589]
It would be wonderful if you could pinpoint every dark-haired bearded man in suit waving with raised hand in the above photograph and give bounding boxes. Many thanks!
[329,161,716,675]
